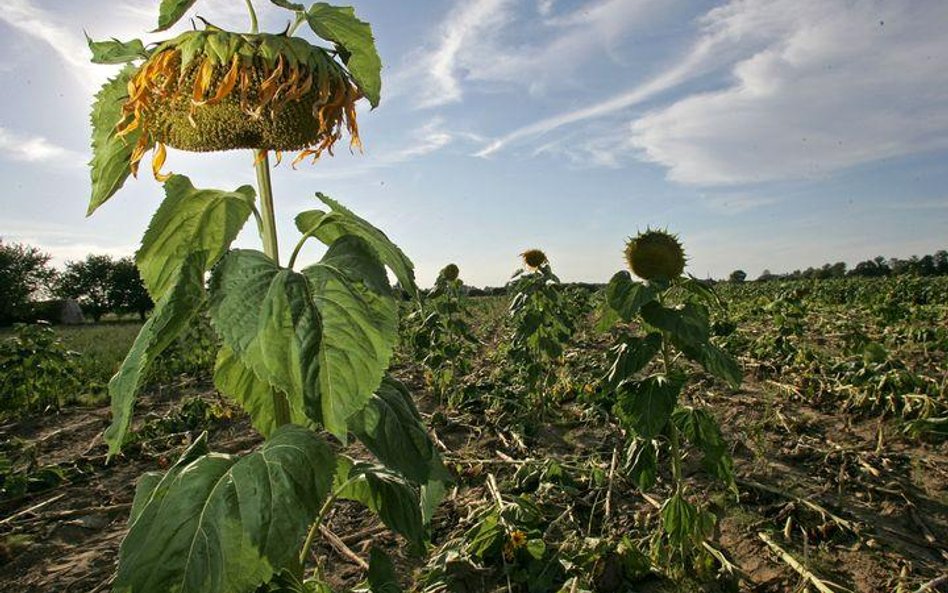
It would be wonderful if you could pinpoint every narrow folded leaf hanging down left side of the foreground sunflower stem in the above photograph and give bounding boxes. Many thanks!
[104,252,206,455]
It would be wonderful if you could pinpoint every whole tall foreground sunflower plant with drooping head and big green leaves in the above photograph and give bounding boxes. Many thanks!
[89,0,449,593]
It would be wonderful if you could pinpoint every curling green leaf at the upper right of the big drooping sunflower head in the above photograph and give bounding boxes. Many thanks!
[306,2,382,107]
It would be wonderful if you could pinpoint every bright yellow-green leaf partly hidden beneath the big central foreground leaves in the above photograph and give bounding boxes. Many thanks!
[214,345,310,437]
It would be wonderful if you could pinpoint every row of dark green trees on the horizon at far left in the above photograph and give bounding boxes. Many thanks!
[0,238,154,325]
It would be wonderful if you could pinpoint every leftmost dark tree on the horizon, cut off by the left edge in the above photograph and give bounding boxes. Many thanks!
[0,239,56,325]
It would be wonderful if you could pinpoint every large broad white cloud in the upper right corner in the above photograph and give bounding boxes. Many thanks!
[631,0,948,185]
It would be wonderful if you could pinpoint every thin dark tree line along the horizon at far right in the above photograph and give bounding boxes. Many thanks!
[728,249,948,282]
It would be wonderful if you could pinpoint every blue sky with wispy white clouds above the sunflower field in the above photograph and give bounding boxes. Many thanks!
[0,0,948,286]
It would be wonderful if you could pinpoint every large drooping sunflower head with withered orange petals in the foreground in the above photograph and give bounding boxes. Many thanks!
[116,30,362,174]
